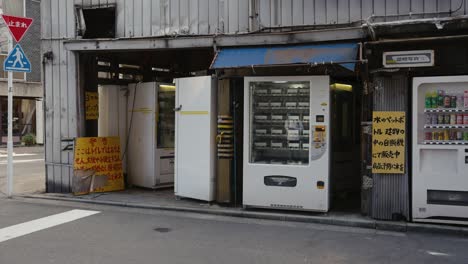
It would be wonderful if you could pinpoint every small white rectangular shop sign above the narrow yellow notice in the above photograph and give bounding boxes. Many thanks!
[383,50,434,68]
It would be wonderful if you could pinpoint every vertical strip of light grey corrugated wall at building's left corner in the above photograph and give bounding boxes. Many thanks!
[41,0,78,192]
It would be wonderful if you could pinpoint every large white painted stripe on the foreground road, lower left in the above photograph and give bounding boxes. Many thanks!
[0,210,100,243]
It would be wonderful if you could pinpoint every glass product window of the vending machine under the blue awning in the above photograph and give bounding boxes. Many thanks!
[250,81,310,165]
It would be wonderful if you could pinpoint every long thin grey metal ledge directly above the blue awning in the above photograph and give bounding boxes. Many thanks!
[60,27,367,51]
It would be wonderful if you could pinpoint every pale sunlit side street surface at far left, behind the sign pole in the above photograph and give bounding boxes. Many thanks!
[0,147,45,197]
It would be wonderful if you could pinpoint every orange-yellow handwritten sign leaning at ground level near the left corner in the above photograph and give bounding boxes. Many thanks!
[72,137,124,194]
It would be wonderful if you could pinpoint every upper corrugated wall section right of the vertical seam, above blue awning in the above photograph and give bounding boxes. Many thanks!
[257,0,468,28]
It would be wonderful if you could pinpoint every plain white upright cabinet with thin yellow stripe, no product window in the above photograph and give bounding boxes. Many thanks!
[174,76,217,201]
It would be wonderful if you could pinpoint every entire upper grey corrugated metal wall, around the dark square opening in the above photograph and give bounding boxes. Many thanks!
[42,0,468,38]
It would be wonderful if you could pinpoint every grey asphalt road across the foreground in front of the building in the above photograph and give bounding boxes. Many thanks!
[0,199,468,264]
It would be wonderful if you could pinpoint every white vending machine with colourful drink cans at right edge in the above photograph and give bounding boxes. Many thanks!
[412,76,468,224]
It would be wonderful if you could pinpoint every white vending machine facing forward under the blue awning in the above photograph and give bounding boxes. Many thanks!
[243,76,330,212]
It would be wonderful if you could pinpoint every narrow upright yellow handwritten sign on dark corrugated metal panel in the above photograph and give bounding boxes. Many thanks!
[372,112,406,174]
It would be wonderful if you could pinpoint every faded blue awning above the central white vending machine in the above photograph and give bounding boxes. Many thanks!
[211,43,359,71]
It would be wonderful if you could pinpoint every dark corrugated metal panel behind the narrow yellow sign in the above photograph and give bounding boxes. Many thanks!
[371,76,410,220]
